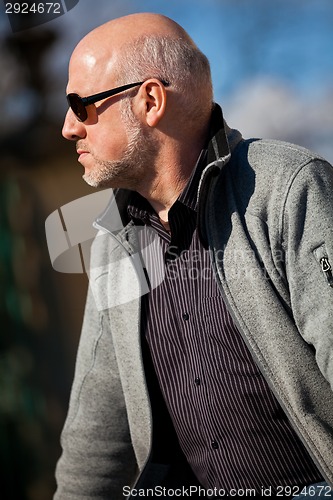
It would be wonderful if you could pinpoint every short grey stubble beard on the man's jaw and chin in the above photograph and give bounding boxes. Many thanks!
[82,100,158,190]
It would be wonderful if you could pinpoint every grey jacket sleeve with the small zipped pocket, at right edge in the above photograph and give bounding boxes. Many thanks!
[281,159,333,389]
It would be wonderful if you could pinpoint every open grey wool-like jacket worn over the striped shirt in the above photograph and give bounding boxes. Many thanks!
[55,106,333,500]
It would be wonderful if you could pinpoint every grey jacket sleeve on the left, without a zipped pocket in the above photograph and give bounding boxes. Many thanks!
[54,287,136,500]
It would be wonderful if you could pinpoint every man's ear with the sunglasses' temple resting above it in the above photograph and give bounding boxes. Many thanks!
[140,79,167,127]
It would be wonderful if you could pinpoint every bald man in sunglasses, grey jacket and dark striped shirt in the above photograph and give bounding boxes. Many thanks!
[55,14,333,500]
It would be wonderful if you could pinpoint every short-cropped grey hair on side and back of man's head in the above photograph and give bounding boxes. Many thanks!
[115,35,213,121]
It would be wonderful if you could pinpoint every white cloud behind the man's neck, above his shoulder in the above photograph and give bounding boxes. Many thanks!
[223,78,333,162]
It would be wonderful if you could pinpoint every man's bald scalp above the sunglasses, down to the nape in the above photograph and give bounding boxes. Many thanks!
[70,13,212,126]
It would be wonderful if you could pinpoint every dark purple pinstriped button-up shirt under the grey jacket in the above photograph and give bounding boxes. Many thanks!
[128,153,322,495]
